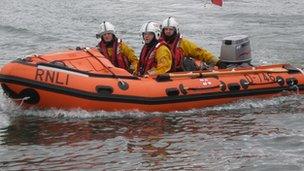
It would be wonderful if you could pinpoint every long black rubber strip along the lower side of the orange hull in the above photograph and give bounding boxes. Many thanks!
[0,75,304,105]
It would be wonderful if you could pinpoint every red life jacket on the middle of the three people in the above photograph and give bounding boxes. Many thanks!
[137,41,167,76]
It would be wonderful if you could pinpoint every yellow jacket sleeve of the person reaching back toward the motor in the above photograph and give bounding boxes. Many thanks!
[179,37,219,65]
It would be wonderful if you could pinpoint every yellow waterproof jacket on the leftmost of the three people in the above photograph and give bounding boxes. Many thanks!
[107,42,138,71]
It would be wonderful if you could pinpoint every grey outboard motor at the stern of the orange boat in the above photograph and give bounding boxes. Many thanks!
[220,35,252,68]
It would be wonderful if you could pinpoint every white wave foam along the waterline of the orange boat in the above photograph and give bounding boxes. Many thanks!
[0,91,304,119]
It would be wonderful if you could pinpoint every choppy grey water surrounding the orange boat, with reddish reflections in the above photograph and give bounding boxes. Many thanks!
[0,0,304,170]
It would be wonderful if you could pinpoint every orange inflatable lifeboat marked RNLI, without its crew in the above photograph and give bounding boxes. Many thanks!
[0,35,304,112]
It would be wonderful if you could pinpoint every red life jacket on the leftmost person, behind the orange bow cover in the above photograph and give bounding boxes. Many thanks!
[98,39,130,71]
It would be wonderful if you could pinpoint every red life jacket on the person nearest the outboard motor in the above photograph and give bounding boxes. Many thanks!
[168,34,184,72]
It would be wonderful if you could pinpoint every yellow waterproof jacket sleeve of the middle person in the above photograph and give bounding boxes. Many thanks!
[148,44,172,75]
